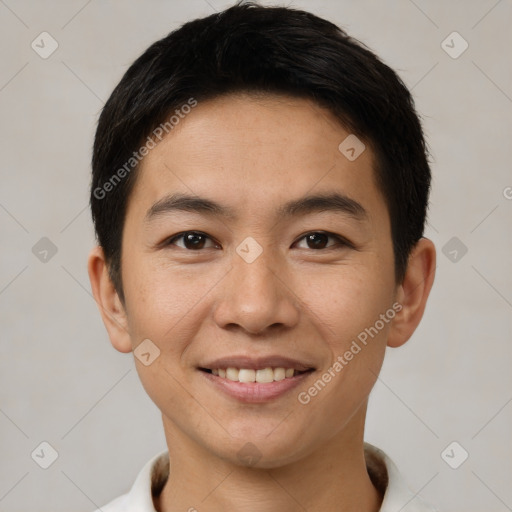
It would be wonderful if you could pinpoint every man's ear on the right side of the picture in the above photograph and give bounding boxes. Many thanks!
[388,238,436,347]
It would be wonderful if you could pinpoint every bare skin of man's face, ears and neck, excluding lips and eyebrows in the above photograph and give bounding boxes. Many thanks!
[88,95,435,512]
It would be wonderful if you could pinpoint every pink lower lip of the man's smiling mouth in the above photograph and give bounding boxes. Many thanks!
[199,370,313,403]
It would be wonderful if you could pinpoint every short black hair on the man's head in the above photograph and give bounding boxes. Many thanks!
[90,2,431,301]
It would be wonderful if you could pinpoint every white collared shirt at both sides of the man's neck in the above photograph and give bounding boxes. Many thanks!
[95,443,437,512]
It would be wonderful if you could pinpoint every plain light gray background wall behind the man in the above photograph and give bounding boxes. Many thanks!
[0,0,512,512]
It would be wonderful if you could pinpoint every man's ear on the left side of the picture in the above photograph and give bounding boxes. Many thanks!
[87,246,132,353]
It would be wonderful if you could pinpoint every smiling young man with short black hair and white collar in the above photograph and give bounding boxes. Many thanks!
[89,3,435,512]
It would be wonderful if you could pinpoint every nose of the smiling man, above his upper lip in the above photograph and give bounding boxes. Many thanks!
[214,251,299,335]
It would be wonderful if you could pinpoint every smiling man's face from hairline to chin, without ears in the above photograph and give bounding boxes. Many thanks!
[118,95,397,467]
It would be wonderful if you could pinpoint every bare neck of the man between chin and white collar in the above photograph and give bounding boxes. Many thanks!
[155,408,382,512]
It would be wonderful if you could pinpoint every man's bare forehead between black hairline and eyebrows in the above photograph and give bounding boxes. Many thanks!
[129,94,386,226]
